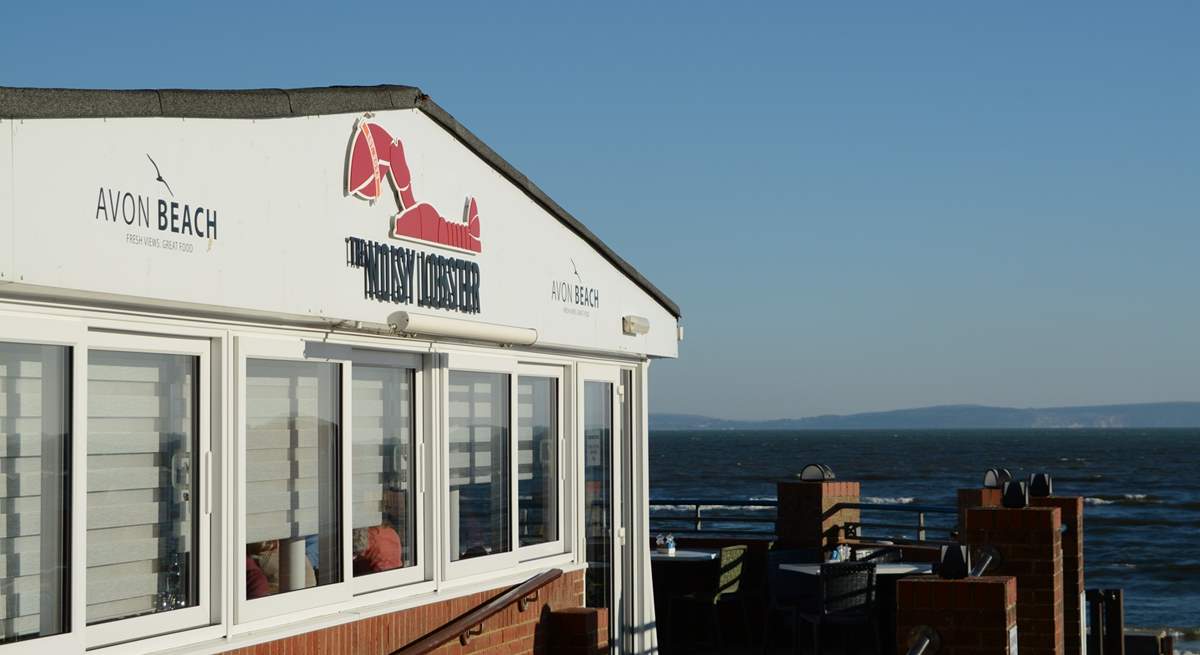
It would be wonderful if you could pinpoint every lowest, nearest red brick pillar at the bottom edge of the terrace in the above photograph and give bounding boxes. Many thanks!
[896,576,1018,655]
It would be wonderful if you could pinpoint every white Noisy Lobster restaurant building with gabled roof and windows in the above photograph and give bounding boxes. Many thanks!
[0,86,680,655]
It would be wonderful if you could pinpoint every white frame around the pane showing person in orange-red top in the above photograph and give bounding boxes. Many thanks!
[343,348,434,595]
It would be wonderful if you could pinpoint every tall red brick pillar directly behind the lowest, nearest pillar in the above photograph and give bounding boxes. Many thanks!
[962,507,1066,655]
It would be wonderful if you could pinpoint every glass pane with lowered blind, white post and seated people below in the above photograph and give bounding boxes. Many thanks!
[245,360,342,599]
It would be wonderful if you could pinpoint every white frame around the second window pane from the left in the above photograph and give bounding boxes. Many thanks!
[83,332,215,648]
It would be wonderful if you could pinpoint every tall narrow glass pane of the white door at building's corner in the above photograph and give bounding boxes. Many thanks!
[583,381,613,607]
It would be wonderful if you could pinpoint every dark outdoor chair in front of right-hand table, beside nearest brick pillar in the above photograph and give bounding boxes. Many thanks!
[798,561,880,655]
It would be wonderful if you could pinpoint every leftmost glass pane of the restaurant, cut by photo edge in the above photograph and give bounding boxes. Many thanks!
[0,343,71,643]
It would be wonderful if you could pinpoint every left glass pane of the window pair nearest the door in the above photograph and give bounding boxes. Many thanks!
[449,371,512,561]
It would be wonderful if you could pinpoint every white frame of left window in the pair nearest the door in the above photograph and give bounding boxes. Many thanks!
[438,353,521,581]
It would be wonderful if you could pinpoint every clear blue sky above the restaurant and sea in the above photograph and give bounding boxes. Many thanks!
[0,0,1200,417]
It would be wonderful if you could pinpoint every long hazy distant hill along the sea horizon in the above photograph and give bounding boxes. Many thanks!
[650,402,1200,429]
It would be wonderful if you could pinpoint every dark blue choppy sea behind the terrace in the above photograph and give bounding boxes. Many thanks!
[649,428,1200,654]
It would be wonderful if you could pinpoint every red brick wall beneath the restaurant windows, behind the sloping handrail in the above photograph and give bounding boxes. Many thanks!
[228,571,583,655]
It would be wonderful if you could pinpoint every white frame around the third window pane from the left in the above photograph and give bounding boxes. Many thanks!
[230,335,354,625]
